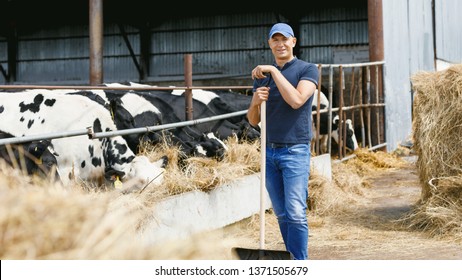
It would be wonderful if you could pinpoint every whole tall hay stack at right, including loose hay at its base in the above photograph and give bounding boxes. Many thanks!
[407,64,462,238]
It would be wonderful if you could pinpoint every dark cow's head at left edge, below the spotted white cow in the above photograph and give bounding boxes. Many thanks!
[0,131,59,180]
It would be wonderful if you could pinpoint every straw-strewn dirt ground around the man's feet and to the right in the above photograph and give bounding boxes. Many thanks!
[218,156,462,260]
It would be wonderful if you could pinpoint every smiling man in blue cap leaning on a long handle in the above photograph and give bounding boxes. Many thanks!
[247,23,319,260]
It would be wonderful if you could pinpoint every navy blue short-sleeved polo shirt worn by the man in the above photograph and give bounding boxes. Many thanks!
[253,57,319,144]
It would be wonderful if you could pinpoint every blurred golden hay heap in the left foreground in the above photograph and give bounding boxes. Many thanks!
[0,162,238,260]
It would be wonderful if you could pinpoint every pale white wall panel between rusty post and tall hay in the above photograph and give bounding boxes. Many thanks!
[382,0,434,151]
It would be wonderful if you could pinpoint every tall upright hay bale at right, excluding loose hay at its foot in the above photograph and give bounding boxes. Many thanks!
[412,64,462,202]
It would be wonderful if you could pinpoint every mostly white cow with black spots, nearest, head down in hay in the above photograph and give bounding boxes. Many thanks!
[0,90,165,190]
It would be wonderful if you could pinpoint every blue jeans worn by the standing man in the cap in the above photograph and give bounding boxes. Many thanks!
[266,144,311,260]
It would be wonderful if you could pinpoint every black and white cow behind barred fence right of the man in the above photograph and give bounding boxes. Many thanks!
[311,90,358,154]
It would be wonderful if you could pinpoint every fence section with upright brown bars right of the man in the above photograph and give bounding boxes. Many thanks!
[313,61,386,160]
